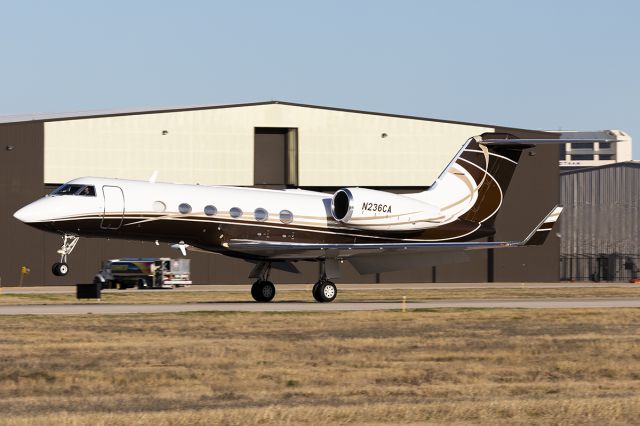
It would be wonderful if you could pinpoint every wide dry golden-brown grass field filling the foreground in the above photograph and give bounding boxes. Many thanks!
[0,309,640,426]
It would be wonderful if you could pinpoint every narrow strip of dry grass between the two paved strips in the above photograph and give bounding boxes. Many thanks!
[0,285,640,307]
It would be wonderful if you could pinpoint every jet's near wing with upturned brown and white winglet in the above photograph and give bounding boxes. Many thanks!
[226,206,562,273]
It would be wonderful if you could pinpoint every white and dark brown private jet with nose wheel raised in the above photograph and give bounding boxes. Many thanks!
[14,134,572,302]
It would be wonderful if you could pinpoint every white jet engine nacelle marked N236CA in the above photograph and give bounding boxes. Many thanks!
[331,188,444,231]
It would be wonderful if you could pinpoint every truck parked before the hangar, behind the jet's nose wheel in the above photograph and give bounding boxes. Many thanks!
[93,257,192,290]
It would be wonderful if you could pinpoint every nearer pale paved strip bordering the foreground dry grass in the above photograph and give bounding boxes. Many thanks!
[0,298,640,315]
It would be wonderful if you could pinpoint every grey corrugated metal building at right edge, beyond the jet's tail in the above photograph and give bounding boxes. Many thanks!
[559,161,640,281]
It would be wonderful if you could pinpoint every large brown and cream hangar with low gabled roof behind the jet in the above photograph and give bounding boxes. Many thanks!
[0,101,560,285]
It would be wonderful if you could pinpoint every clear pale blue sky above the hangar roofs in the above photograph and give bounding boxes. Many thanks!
[0,0,640,159]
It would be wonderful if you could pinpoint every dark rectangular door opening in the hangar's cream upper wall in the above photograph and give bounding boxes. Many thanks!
[253,127,298,188]
